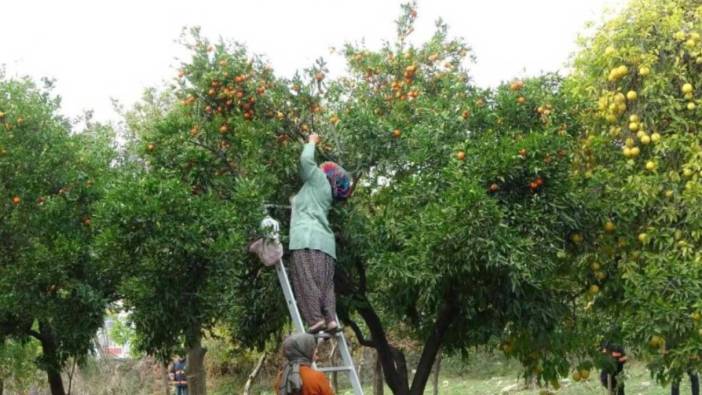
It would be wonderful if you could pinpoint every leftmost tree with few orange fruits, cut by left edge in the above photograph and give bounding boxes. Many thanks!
[0,78,114,395]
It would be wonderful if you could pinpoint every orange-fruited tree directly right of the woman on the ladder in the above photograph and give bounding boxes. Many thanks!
[319,4,591,394]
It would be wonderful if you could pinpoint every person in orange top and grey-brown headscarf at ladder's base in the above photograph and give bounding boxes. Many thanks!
[275,333,334,395]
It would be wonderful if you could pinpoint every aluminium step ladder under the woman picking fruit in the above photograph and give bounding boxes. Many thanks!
[261,215,363,395]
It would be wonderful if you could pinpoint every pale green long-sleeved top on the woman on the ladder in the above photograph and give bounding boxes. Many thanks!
[290,143,336,259]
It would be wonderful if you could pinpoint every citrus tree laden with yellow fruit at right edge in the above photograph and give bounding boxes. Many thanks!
[569,0,702,381]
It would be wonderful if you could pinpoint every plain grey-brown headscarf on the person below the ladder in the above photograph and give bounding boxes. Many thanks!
[278,333,317,395]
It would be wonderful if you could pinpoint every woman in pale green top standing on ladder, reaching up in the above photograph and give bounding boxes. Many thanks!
[289,133,351,333]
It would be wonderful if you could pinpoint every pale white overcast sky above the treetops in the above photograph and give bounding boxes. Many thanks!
[0,0,624,125]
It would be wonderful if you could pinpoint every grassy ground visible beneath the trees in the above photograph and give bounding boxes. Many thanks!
[62,353,690,395]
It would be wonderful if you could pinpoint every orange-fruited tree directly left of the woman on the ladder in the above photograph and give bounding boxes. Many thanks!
[96,29,312,394]
